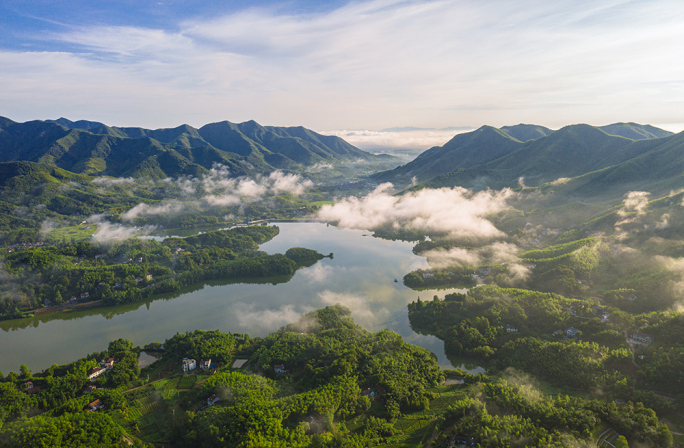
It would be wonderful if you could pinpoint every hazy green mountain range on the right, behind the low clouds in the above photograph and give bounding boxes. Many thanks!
[375,123,684,194]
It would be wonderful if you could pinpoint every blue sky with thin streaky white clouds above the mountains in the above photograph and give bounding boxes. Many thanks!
[0,0,684,135]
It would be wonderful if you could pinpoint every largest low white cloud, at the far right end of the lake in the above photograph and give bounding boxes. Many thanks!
[318,184,513,239]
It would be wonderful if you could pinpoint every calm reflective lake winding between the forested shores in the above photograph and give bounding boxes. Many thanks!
[0,223,464,375]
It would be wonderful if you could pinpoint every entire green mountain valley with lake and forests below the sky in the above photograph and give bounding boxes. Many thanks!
[0,120,684,447]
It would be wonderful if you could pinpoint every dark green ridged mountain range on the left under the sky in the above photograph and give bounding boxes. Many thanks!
[0,117,392,178]
